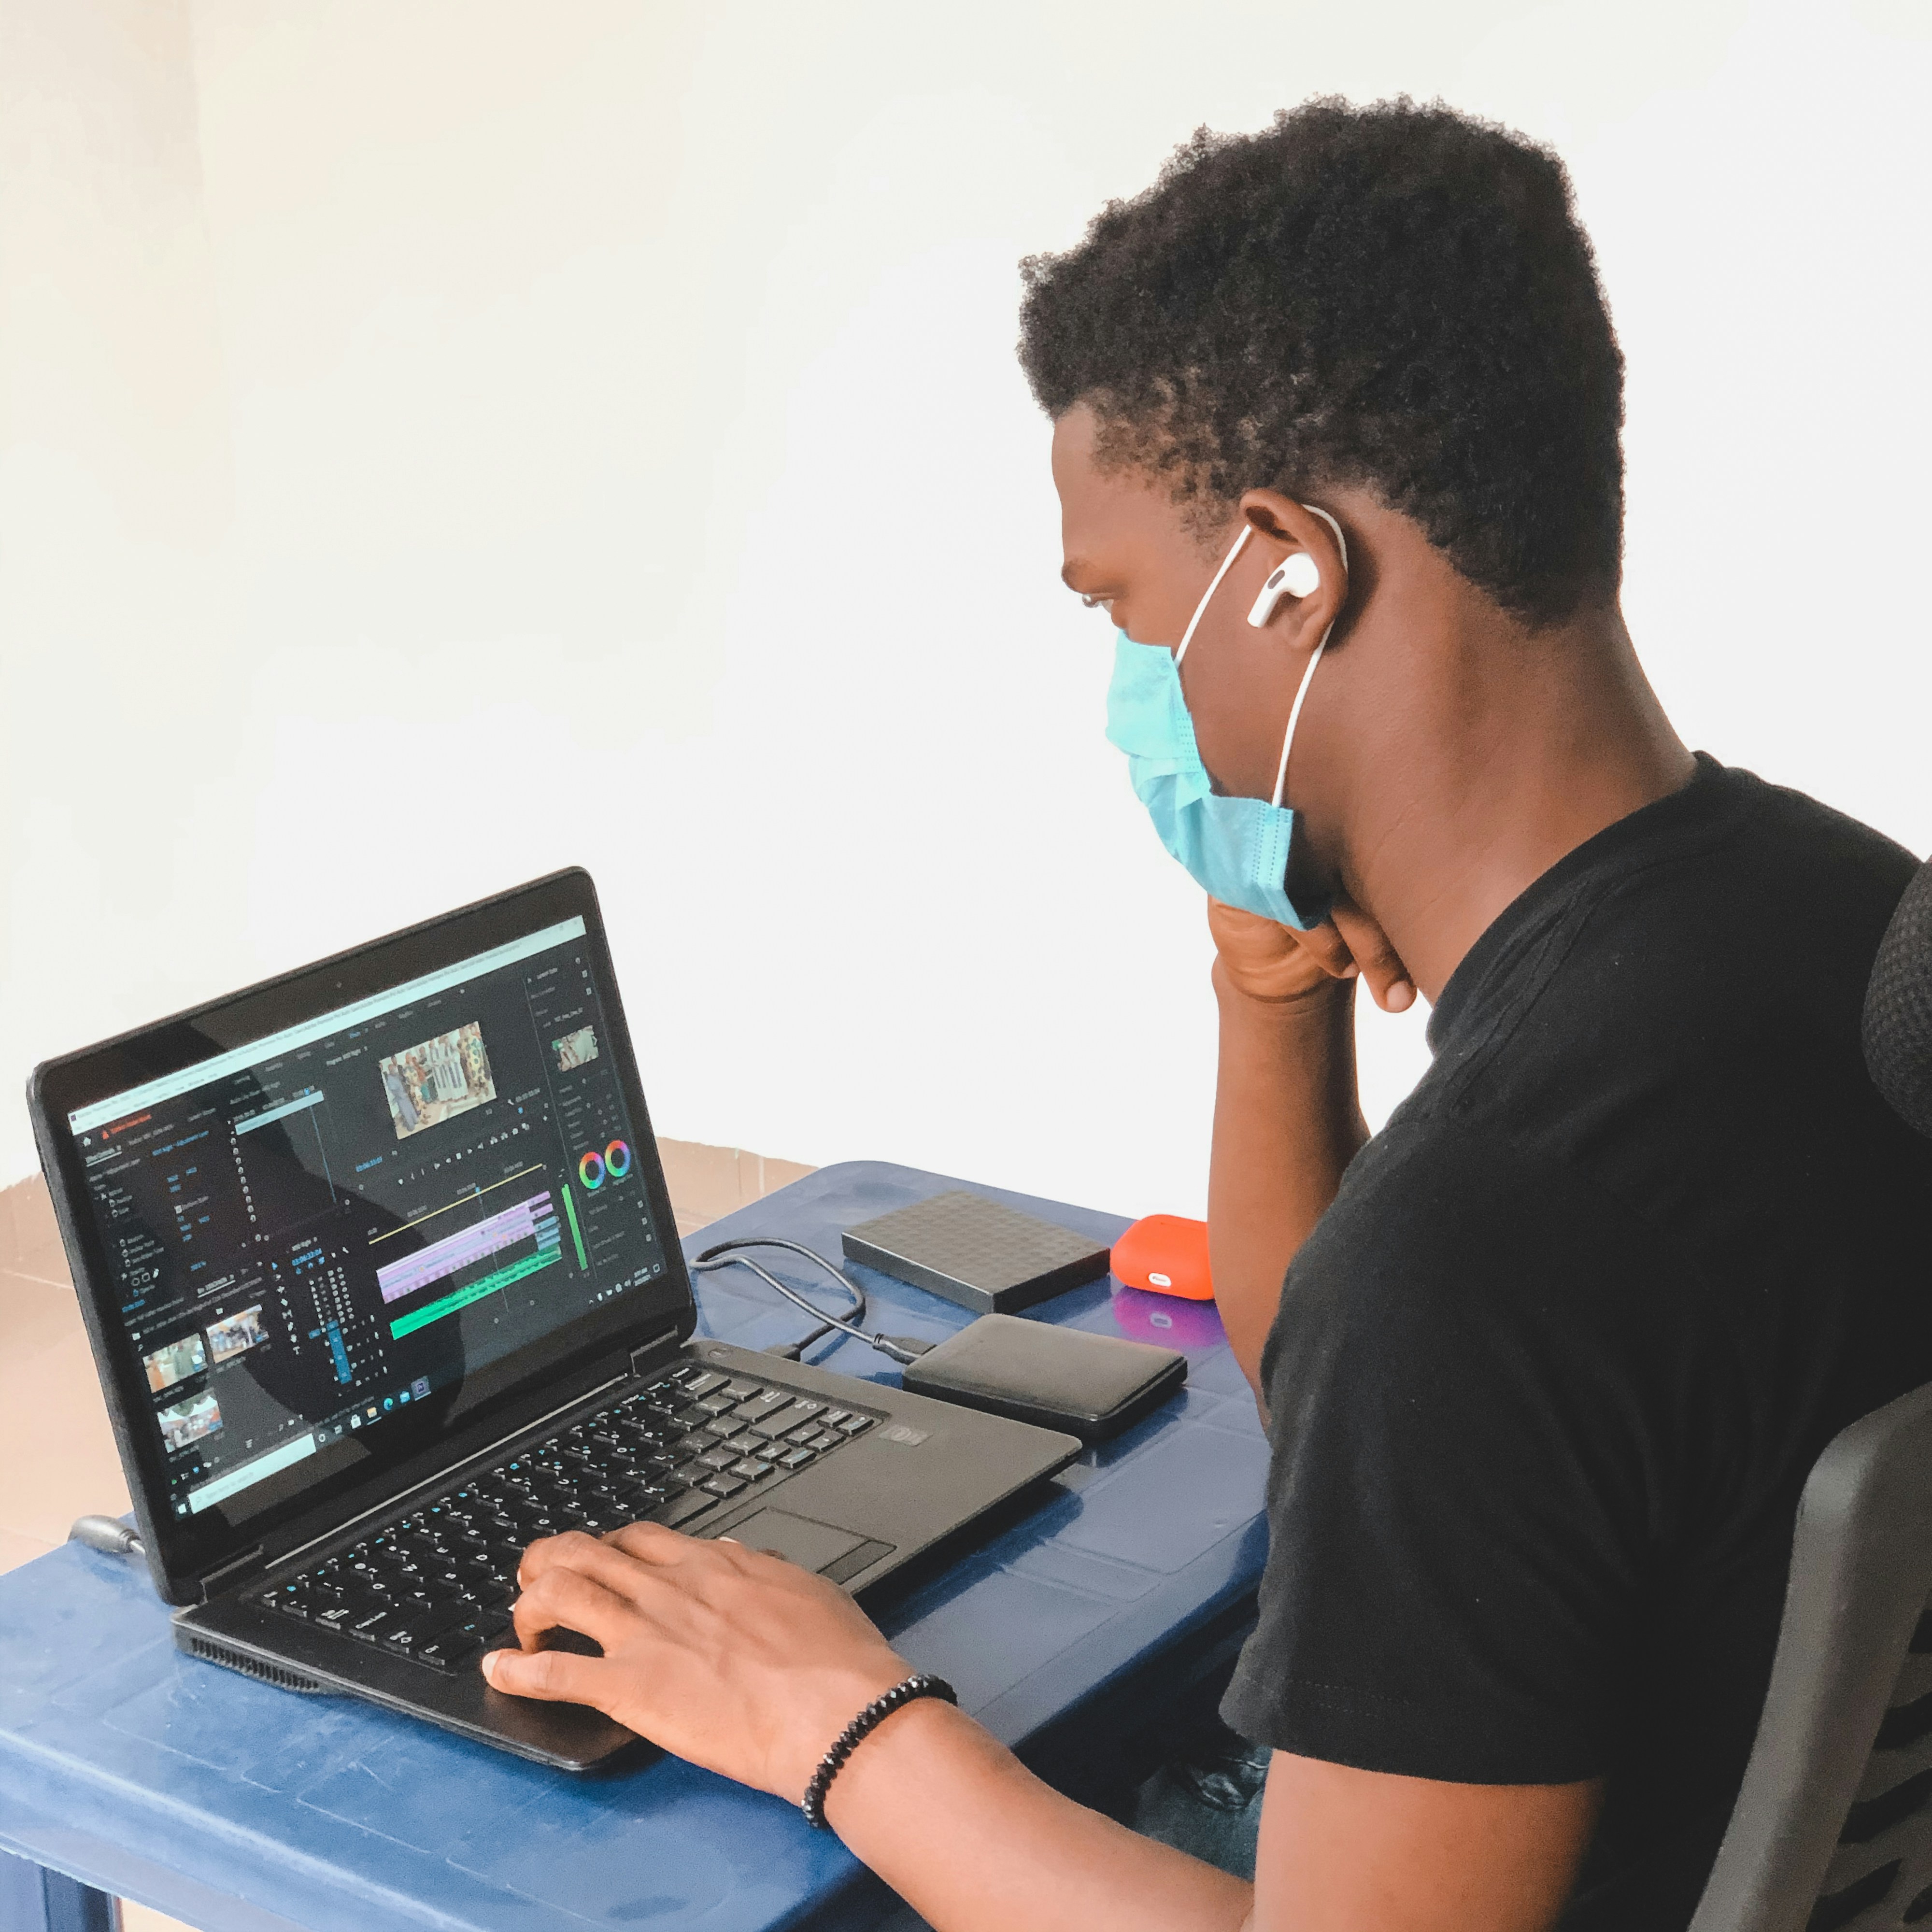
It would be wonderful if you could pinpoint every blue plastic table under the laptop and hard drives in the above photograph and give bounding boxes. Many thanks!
[0,1161,1267,1932]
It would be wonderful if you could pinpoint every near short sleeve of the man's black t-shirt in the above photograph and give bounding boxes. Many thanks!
[1223,1128,1681,1783]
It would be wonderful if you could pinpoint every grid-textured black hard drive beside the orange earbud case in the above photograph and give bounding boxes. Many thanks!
[844,1188,1109,1316]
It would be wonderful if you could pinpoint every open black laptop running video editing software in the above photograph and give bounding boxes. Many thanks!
[29,869,1080,1770]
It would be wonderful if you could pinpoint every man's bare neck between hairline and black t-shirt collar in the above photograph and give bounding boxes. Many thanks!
[1343,607,1696,1003]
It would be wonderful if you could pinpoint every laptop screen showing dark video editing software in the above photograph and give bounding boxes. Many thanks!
[68,918,665,1517]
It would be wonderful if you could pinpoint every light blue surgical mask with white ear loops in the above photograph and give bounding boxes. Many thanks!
[1107,504,1349,931]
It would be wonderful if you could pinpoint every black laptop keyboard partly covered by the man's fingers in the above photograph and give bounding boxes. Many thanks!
[255,1362,877,1671]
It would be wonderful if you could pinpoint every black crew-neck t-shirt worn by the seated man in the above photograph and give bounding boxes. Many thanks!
[1223,753,1932,1932]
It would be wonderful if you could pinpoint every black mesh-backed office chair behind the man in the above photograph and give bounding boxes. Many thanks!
[1690,864,1932,1932]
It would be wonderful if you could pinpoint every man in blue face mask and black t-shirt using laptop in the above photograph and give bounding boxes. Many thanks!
[471,102,1932,1932]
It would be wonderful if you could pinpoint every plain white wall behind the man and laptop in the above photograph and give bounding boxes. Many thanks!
[0,0,1932,1211]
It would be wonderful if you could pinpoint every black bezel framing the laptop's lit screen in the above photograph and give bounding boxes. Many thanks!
[27,867,697,1604]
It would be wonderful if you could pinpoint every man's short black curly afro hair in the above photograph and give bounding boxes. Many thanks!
[1020,99,1623,626]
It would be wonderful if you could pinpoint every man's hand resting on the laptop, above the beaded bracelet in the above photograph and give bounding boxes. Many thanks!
[483,1522,912,1804]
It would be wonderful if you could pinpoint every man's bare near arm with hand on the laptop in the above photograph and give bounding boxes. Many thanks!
[489,1524,1596,1932]
